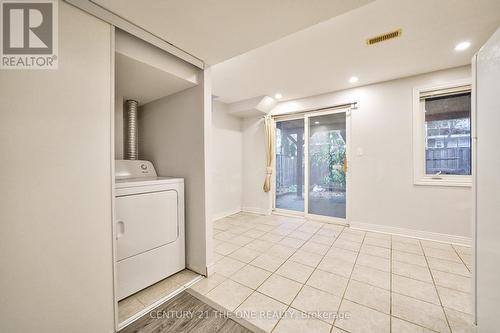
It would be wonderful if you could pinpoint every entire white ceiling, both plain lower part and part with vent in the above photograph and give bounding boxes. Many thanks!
[93,0,500,103]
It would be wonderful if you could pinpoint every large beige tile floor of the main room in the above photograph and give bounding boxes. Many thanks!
[192,213,473,333]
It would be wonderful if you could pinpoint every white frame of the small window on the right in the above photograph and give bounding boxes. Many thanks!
[413,79,475,187]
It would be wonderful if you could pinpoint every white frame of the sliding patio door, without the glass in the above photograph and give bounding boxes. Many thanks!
[272,106,352,225]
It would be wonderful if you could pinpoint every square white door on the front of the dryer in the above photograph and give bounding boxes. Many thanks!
[116,190,179,260]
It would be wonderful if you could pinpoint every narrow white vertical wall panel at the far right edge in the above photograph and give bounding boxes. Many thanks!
[475,29,500,333]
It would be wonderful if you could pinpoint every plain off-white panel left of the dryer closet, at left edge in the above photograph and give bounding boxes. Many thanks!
[0,1,114,333]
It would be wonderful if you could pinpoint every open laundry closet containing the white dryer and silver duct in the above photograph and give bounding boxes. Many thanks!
[113,28,208,329]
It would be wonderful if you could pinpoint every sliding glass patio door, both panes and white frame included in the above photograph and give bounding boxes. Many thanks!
[273,108,350,223]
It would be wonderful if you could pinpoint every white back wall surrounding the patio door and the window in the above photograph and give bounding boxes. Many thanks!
[243,66,472,237]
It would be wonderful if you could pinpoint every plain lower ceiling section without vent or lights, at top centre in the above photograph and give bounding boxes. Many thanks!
[92,0,374,64]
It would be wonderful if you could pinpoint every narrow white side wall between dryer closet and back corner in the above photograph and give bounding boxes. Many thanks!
[211,101,243,220]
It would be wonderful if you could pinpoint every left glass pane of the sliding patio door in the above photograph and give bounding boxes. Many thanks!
[275,118,305,213]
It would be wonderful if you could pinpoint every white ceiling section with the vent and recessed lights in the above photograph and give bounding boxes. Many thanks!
[212,0,500,103]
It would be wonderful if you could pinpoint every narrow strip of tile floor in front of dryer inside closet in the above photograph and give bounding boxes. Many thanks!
[118,269,199,322]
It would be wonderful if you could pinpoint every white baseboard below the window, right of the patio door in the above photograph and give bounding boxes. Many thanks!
[350,221,472,246]
